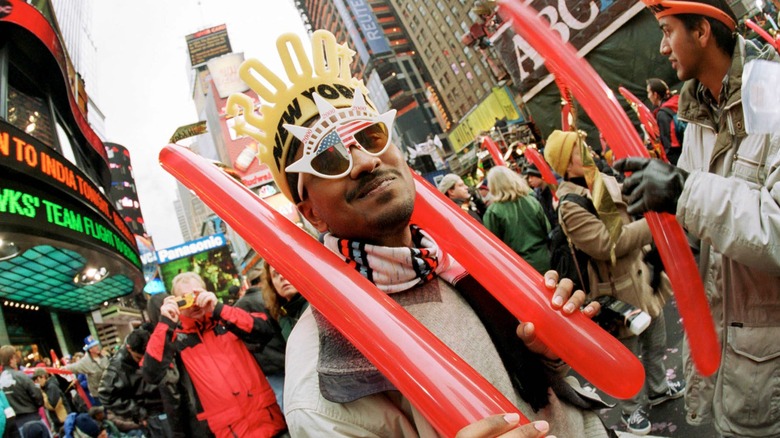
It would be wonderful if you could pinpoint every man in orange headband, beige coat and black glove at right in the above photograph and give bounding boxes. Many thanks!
[615,0,780,437]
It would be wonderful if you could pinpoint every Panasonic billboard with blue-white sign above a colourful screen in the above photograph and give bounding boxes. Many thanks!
[157,234,241,301]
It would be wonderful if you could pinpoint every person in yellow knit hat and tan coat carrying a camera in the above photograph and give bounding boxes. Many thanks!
[544,131,685,435]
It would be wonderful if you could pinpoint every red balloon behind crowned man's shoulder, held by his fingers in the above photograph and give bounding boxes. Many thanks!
[412,175,645,398]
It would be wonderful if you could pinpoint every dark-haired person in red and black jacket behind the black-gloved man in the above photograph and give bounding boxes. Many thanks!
[647,78,683,166]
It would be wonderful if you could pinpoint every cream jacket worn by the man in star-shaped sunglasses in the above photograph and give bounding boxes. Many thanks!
[284,286,607,438]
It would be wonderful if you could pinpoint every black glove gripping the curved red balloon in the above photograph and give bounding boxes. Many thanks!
[613,157,688,214]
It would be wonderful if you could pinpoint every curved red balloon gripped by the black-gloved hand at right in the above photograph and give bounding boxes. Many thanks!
[500,0,720,376]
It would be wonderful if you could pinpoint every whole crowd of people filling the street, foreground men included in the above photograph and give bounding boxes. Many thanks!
[0,0,780,438]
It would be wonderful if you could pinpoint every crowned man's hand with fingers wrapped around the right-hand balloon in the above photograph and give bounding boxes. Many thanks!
[517,271,601,360]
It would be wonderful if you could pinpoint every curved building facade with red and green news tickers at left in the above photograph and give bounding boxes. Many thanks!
[0,0,144,357]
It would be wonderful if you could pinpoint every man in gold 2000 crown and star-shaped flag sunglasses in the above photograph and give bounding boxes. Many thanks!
[228,30,620,437]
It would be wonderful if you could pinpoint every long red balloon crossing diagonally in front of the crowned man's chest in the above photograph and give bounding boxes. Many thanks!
[160,145,528,436]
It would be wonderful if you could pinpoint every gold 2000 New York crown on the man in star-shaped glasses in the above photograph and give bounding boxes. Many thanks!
[227,30,375,200]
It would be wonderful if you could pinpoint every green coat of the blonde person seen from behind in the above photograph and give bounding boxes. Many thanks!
[482,193,550,273]
